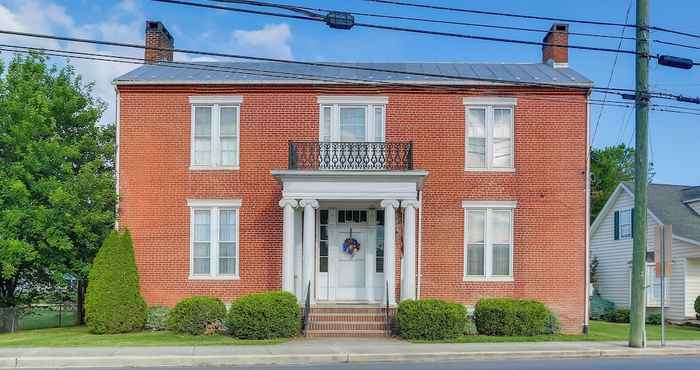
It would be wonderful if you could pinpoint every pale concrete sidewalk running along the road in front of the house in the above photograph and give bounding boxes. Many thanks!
[0,338,700,368]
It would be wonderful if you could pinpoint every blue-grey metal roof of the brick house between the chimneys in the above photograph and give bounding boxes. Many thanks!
[114,62,593,87]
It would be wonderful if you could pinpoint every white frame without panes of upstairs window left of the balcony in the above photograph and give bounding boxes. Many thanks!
[189,96,243,171]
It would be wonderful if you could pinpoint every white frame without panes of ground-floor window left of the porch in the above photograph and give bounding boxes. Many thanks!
[187,199,241,280]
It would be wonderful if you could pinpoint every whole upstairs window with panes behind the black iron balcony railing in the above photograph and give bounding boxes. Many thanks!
[318,96,389,142]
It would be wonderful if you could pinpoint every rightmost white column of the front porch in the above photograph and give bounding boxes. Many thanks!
[401,200,419,300]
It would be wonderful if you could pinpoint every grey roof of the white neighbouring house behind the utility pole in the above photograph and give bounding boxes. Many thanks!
[624,181,700,242]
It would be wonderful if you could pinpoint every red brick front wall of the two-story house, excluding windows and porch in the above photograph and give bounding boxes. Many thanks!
[119,86,587,332]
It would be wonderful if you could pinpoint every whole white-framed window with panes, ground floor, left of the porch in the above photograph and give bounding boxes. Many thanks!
[187,199,241,279]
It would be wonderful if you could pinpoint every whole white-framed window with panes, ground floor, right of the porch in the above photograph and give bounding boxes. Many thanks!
[462,201,515,281]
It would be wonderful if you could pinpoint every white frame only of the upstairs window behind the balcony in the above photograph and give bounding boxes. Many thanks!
[317,96,389,142]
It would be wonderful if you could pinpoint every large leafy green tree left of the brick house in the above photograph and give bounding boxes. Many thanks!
[0,54,116,320]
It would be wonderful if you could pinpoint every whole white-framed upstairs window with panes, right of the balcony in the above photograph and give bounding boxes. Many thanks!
[464,98,516,171]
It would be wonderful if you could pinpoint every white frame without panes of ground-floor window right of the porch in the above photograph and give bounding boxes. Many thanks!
[462,201,517,282]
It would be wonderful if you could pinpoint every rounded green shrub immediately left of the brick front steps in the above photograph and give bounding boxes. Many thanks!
[226,292,301,339]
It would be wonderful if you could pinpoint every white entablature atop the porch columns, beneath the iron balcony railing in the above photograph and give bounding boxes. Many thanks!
[271,170,428,200]
